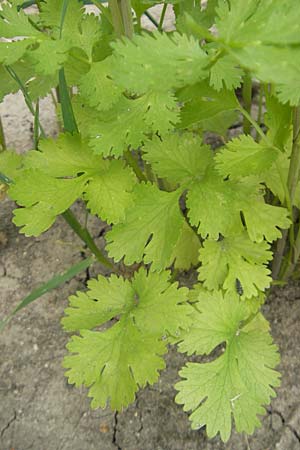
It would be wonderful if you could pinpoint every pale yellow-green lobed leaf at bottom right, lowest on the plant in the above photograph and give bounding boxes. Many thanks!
[175,293,280,442]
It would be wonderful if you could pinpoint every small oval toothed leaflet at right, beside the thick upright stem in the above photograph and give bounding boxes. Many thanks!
[216,135,280,179]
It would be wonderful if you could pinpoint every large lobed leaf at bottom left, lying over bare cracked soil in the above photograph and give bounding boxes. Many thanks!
[62,269,191,410]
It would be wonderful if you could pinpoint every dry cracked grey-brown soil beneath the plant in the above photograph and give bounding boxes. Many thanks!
[0,6,300,450]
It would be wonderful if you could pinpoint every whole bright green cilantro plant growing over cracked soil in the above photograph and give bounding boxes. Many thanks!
[0,0,300,441]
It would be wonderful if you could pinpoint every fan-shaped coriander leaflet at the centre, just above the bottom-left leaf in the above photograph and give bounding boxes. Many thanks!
[106,184,184,270]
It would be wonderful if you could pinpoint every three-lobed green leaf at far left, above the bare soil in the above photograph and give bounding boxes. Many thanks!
[9,134,136,236]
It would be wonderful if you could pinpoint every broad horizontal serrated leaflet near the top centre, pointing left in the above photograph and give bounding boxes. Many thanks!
[112,32,209,94]
